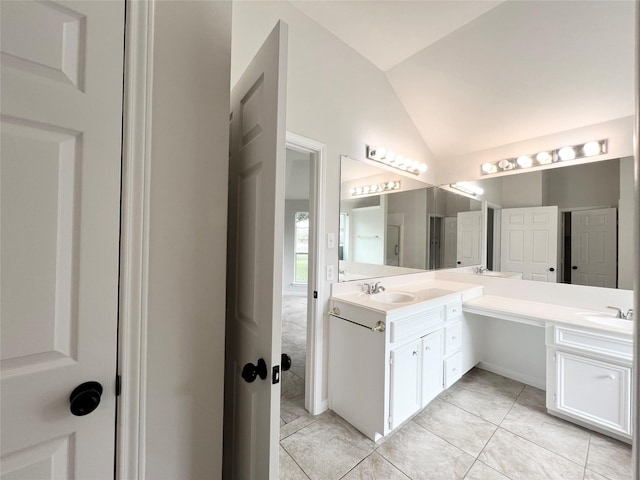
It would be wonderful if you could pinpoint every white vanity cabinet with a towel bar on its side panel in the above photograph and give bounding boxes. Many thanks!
[329,294,463,440]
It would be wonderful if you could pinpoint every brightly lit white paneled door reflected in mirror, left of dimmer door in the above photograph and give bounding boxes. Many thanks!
[500,206,558,282]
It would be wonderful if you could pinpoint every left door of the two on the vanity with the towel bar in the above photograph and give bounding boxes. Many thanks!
[389,340,422,428]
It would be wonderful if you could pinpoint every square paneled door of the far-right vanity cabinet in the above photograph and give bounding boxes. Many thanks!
[556,352,631,434]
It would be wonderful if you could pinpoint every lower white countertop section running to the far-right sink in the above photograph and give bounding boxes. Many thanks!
[463,295,633,335]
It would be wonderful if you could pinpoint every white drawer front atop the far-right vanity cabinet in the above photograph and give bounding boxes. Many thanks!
[547,325,633,362]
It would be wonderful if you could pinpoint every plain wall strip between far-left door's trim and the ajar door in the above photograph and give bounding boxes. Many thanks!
[143,1,231,480]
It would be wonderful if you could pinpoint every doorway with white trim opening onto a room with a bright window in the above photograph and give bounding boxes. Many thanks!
[280,133,325,425]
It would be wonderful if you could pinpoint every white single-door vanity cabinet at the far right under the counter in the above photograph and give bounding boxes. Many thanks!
[546,325,633,440]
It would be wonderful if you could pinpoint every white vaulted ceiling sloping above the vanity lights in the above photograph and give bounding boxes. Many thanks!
[291,0,634,158]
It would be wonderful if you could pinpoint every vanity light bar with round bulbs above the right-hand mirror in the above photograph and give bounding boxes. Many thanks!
[480,140,608,175]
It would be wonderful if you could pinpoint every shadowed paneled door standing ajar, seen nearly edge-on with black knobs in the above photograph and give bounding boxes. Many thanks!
[222,22,287,480]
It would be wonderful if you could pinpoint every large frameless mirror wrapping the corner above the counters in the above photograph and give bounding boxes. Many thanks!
[339,157,635,289]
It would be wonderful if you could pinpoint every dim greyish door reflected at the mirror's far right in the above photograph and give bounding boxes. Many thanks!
[571,208,616,288]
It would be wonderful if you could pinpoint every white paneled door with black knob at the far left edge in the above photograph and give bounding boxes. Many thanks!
[0,1,124,479]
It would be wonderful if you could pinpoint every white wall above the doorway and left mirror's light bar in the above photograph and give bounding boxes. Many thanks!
[231,1,435,401]
